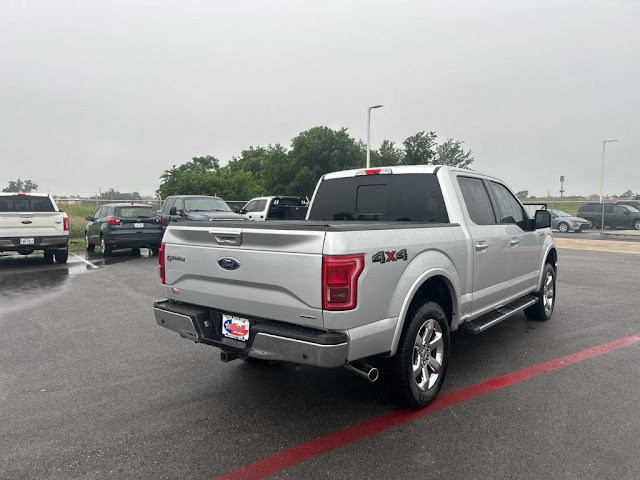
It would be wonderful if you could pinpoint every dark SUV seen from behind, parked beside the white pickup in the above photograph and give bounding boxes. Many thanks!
[84,203,162,256]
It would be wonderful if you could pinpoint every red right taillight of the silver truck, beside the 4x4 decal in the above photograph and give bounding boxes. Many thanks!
[322,254,364,310]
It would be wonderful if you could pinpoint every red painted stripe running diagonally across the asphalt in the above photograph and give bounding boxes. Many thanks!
[217,333,640,480]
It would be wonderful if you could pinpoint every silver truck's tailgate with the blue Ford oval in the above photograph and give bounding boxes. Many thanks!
[163,222,325,327]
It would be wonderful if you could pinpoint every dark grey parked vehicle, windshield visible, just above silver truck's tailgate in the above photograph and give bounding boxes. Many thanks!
[161,195,242,229]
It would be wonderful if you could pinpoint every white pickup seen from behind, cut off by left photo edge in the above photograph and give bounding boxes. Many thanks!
[0,193,69,263]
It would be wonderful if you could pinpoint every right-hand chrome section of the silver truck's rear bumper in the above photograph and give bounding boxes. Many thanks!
[249,332,349,367]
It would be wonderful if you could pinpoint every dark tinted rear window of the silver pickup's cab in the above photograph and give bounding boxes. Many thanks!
[309,173,449,223]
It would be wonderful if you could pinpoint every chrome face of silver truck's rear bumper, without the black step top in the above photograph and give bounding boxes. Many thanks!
[154,304,349,367]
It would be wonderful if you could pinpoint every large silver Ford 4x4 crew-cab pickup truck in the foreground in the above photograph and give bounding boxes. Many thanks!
[154,166,557,408]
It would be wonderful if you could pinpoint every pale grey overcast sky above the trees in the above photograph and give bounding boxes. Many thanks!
[0,0,640,194]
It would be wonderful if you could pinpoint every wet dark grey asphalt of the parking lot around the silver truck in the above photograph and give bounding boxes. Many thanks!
[0,249,640,479]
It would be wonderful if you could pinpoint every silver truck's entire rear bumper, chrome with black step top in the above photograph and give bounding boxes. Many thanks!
[154,300,349,367]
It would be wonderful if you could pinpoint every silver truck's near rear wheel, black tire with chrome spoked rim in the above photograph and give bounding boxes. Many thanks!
[384,302,450,409]
